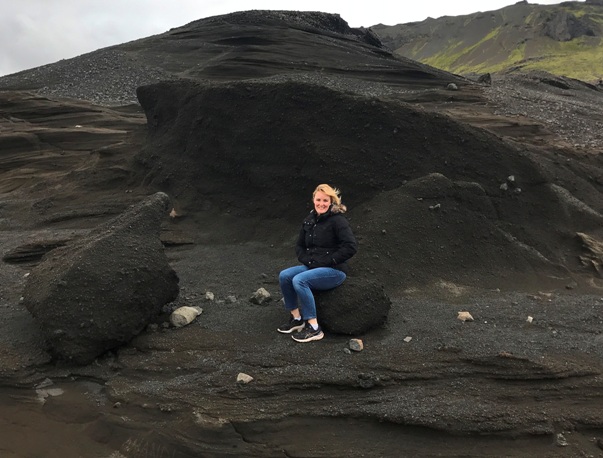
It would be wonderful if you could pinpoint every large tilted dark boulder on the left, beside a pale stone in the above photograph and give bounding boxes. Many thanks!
[23,193,179,364]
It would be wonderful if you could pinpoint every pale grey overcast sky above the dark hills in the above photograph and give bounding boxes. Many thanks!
[0,0,576,76]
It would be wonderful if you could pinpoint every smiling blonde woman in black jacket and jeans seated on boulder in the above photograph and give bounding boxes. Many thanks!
[277,184,356,342]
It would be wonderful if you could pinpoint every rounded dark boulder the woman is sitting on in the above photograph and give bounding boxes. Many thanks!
[314,277,391,335]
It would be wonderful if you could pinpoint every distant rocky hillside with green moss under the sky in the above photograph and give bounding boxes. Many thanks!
[372,0,603,82]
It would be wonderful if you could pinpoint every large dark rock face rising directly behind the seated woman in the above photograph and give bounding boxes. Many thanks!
[137,74,603,289]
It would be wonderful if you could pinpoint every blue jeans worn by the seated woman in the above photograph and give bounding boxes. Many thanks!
[278,265,346,320]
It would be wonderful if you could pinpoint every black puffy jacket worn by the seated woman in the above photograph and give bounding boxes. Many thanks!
[295,209,356,272]
